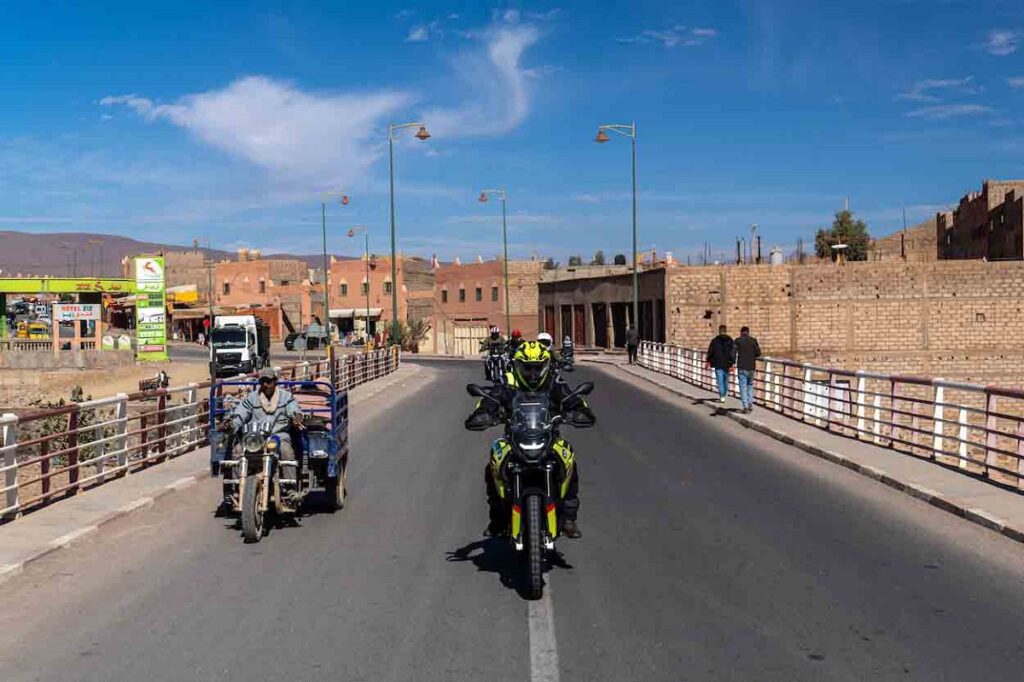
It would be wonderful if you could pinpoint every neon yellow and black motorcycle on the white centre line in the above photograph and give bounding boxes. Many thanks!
[466,382,594,599]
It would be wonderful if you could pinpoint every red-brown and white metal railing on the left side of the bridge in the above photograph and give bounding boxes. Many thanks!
[0,346,401,520]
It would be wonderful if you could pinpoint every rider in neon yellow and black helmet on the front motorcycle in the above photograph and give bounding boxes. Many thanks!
[466,341,597,539]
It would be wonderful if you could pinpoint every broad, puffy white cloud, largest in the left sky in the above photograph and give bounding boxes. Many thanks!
[99,76,412,183]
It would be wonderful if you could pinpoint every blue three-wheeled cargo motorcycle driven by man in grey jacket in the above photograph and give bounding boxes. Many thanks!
[210,381,348,543]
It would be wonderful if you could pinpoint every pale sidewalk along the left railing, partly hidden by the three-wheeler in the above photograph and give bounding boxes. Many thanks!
[0,364,424,584]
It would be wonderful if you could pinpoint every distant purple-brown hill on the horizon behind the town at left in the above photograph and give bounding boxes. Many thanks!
[0,230,350,276]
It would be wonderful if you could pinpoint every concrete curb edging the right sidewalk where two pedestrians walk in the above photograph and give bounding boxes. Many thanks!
[604,363,1024,543]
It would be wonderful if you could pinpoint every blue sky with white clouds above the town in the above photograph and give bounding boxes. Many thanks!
[0,0,1024,260]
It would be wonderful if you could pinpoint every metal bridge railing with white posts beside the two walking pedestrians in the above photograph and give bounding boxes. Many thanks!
[638,341,1024,491]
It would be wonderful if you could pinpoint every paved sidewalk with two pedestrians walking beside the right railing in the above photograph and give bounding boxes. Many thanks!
[590,358,1024,543]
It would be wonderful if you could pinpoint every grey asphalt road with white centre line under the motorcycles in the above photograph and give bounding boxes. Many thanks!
[0,363,1024,682]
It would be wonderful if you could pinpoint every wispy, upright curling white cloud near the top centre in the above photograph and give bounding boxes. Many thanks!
[423,10,541,135]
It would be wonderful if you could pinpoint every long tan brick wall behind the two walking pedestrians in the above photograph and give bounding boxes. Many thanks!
[666,261,1024,384]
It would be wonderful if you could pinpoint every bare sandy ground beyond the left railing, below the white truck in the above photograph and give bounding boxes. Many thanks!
[0,359,210,411]
